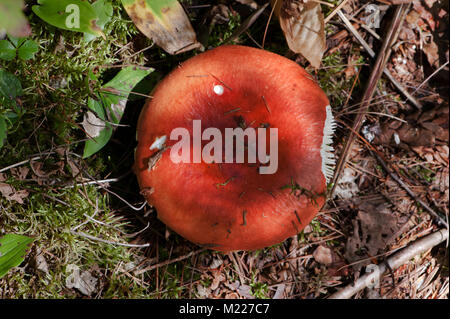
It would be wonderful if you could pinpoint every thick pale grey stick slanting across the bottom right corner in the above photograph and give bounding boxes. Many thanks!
[328,229,448,299]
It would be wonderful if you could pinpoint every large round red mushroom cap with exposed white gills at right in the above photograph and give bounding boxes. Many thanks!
[134,45,335,251]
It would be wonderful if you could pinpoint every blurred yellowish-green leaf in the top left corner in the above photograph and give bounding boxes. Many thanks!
[0,0,31,37]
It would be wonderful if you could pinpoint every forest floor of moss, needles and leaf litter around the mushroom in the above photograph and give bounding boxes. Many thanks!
[0,0,449,299]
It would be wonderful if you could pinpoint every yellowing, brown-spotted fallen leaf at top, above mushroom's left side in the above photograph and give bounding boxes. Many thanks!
[122,0,201,55]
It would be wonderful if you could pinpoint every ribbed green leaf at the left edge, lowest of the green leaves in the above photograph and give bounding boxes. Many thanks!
[0,234,33,278]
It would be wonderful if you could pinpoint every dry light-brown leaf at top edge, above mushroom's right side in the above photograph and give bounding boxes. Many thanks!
[271,0,326,68]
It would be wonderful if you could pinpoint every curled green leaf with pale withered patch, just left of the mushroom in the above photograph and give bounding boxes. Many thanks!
[83,67,153,158]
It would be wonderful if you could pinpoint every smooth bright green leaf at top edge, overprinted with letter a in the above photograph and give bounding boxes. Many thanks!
[32,0,104,36]
